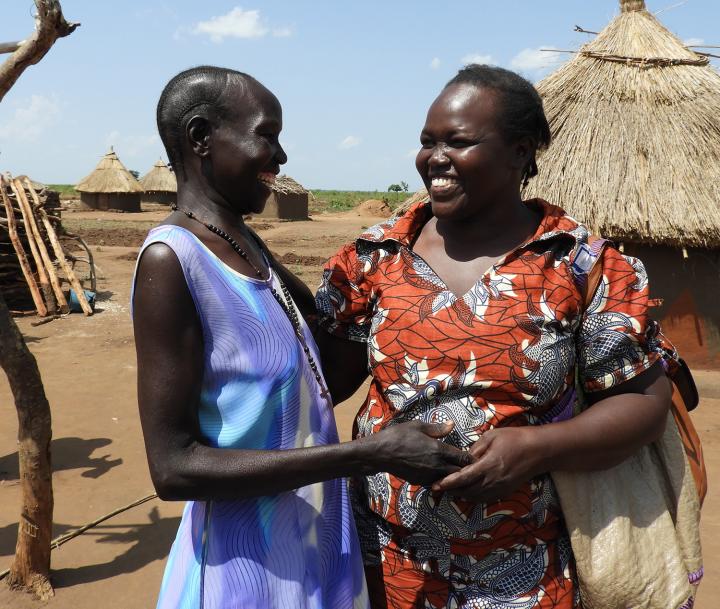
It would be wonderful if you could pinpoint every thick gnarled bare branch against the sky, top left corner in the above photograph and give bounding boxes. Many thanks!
[0,0,80,101]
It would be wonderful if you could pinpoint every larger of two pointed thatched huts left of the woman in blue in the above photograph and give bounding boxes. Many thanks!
[75,148,143,211]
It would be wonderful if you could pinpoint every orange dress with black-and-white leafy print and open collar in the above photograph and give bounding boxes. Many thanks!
[317,200,658,609]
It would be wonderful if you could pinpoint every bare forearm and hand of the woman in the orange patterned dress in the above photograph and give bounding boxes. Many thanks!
[433,364,671,501]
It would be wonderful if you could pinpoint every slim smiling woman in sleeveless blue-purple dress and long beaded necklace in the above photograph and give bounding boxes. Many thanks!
[132,66,470,609]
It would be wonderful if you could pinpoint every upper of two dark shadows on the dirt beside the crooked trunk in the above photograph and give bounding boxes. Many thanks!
[0,437,122,481]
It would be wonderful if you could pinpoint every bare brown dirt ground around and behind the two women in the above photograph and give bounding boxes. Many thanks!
[0,212,720,609]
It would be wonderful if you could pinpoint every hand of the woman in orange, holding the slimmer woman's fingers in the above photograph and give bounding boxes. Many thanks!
[432,427,541,503]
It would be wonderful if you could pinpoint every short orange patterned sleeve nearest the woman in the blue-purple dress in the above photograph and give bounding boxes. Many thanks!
[315,243,373,342]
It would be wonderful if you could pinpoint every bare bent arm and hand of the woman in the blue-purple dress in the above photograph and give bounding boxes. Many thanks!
[134,244,470,500]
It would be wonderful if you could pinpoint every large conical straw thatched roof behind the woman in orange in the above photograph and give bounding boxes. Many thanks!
[523,0,720,247]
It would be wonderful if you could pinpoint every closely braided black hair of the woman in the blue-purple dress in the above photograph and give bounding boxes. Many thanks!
[157,66,257,180]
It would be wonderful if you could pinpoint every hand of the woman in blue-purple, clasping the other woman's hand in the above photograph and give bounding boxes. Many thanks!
[363,421,474,486]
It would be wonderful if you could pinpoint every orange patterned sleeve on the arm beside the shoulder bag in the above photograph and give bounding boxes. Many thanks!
[577,247,660,392]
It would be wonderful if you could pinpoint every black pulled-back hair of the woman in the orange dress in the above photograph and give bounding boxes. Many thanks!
[445,63,552,186]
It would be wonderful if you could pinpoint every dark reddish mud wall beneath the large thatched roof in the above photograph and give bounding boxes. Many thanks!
[624,243,720,370]
